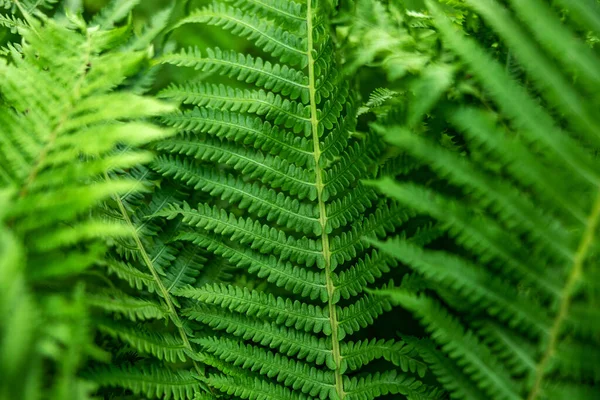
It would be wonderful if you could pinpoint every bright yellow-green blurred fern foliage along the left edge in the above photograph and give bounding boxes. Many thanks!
[0,10,172,400]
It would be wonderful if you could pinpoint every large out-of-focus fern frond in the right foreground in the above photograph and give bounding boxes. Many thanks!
[376,0,600,400]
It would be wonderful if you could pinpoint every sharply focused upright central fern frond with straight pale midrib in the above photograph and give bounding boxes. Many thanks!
[124,0,434,400]
